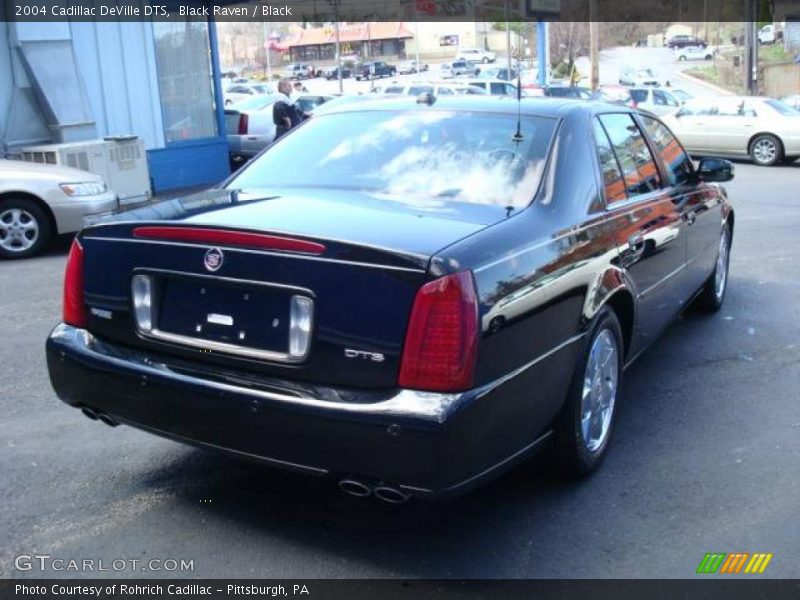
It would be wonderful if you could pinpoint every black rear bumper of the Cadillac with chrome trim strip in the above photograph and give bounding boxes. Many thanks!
[47,324,549,498]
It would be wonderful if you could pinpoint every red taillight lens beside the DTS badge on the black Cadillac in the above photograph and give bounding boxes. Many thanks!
[398,271,478,392]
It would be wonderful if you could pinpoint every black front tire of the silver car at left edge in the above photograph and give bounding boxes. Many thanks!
[0,197,52,258]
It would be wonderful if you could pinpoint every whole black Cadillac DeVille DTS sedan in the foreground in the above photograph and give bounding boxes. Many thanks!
[47,97,734,502]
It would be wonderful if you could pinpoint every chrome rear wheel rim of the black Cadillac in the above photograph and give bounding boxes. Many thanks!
[581,329,619,452]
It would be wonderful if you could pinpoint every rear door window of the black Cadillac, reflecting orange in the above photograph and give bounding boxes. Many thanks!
[600,113,660,197]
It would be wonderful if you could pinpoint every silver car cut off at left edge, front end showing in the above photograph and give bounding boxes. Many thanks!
[0,159,119,258]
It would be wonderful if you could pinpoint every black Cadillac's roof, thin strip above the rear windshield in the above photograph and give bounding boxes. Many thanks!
[306,95,633,119]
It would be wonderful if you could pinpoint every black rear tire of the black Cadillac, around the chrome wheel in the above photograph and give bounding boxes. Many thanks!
[554,307,625,478]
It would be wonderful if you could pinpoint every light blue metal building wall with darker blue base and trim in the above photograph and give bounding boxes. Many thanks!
[0,22,230,193]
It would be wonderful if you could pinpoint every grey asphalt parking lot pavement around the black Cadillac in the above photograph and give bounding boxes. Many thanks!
[0,162,800,578]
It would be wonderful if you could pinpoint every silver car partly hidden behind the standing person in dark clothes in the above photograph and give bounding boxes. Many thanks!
[225,94,333,168]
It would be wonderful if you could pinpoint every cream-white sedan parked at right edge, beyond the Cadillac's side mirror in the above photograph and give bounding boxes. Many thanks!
[664,96,800,166]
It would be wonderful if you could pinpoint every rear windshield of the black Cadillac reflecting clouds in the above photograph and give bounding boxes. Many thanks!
[229,110,555,208]
